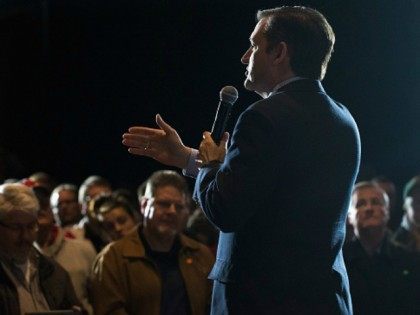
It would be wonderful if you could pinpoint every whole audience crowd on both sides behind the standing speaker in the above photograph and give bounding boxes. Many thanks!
[0,170,420,315]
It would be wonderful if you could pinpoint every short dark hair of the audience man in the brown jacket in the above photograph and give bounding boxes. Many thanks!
[144,170,190,200]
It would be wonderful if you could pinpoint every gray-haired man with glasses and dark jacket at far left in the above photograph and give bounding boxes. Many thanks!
[0,184,81,315]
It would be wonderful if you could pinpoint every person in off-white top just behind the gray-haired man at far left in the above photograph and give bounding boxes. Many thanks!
[33,187,96,314]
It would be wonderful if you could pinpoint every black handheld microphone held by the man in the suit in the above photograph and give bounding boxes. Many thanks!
[211,85,238,144]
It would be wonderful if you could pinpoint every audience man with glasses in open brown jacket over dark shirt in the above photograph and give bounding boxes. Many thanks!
[92,171,214,315]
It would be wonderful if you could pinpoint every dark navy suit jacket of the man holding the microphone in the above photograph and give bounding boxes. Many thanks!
[195,79,360,314]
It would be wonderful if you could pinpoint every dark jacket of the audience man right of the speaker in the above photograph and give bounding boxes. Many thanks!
[343,235,420,315]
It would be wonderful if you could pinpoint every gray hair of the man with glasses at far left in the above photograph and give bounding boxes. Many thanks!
[0,183,39,221]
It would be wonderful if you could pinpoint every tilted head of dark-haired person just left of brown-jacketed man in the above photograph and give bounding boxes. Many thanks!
[98,197,138,241]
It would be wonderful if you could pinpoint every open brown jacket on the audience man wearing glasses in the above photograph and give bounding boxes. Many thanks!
[92,230,214,315]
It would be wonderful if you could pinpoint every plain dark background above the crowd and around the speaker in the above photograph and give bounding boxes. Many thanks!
[0,0,420,193]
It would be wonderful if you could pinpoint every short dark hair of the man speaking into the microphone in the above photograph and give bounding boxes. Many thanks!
[257,6,335,80]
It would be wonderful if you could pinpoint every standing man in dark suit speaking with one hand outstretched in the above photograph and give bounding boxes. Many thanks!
[123,7,360,314]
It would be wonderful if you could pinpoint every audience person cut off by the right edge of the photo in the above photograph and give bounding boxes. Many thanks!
[394,176,420,252]
